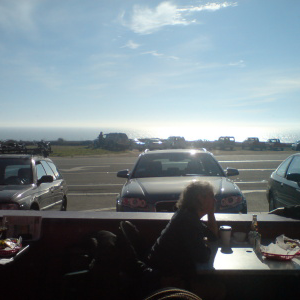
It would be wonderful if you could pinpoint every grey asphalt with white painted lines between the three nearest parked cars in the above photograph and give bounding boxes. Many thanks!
[52,151,292,213]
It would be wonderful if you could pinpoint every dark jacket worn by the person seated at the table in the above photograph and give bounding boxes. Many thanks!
[148,209,215,275]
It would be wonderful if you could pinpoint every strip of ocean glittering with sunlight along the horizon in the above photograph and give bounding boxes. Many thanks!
[0,127,300,143]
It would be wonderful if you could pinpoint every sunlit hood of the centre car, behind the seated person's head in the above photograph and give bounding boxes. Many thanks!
[122,176,241,202]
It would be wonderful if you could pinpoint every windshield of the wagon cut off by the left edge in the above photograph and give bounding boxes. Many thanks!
[0,158,32,185]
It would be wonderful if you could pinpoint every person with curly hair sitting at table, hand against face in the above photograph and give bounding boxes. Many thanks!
[148,182,225,299]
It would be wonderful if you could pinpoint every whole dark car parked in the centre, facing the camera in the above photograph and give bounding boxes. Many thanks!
[116,149,247,213]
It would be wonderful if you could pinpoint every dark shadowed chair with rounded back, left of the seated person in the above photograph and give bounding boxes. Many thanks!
[62,230,120,300]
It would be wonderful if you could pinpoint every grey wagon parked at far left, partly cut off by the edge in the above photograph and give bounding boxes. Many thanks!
[0,145,68,211]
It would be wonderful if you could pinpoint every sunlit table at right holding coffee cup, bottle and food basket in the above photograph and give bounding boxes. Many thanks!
[197,244,300,300]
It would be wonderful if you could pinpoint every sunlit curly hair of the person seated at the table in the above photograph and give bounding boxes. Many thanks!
[176,181,214,211]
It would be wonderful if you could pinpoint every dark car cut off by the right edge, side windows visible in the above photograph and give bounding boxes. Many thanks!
[267,153,300,211]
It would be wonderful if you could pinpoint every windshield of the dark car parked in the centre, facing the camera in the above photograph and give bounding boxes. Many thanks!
[132,153,224,178]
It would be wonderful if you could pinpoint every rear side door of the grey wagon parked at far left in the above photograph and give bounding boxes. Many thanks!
[41,160,63,210]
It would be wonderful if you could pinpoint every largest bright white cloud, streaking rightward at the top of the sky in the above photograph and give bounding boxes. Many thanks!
[121,2,237,34]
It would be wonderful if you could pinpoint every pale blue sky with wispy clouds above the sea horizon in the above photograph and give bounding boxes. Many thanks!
[0,0,300,140]
